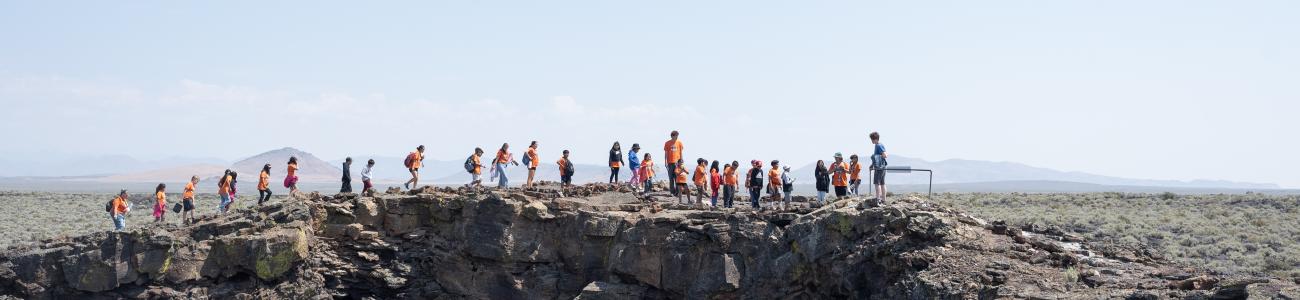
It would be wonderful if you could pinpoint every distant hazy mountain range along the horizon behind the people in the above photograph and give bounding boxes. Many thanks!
[0,148,1279,190]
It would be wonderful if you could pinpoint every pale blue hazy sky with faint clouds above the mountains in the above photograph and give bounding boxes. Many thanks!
[0,0,1300,187]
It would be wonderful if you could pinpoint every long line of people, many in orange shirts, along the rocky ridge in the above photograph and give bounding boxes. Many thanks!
[114,131,888,230]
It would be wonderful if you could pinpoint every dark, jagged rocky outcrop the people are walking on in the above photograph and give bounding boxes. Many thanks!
[0,184,1300,299]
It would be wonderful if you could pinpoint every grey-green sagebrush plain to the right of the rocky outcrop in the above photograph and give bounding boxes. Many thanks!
[935,192,1300,277]
